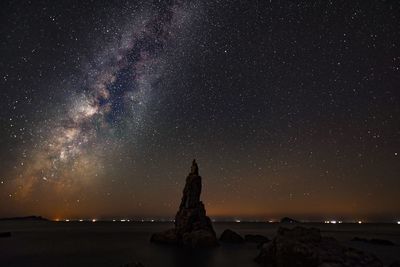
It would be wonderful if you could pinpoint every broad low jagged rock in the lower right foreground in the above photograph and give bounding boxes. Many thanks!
[255,227,383,267]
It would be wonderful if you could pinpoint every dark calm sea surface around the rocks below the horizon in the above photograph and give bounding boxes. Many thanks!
[0,221,400,267]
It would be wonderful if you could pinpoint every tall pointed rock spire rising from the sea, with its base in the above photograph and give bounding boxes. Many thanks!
[151,160,218,247]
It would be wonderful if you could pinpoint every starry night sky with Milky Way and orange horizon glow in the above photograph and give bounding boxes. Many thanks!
[0,0,400,221]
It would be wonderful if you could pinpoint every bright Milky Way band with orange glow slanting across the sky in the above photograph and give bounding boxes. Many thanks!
[1,1,198,199]
